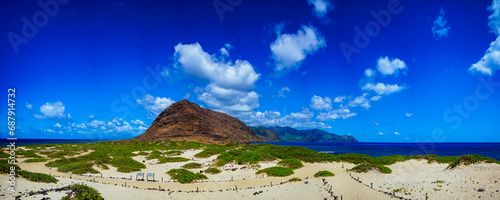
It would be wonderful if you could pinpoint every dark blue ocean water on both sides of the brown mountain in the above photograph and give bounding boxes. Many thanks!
[1,138,500,160]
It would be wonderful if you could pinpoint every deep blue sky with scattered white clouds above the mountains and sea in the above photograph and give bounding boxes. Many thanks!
[0,0,500,142]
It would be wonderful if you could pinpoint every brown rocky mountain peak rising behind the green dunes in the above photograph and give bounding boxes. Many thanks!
[132,99,260,143]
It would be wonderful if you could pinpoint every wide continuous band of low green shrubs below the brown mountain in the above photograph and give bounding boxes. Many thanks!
[14,140,499,177]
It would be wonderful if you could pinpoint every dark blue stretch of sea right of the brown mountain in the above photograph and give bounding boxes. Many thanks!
[258,142,500,160]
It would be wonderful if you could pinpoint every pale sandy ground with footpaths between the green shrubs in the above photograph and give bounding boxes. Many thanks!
[0,150,500,200]
